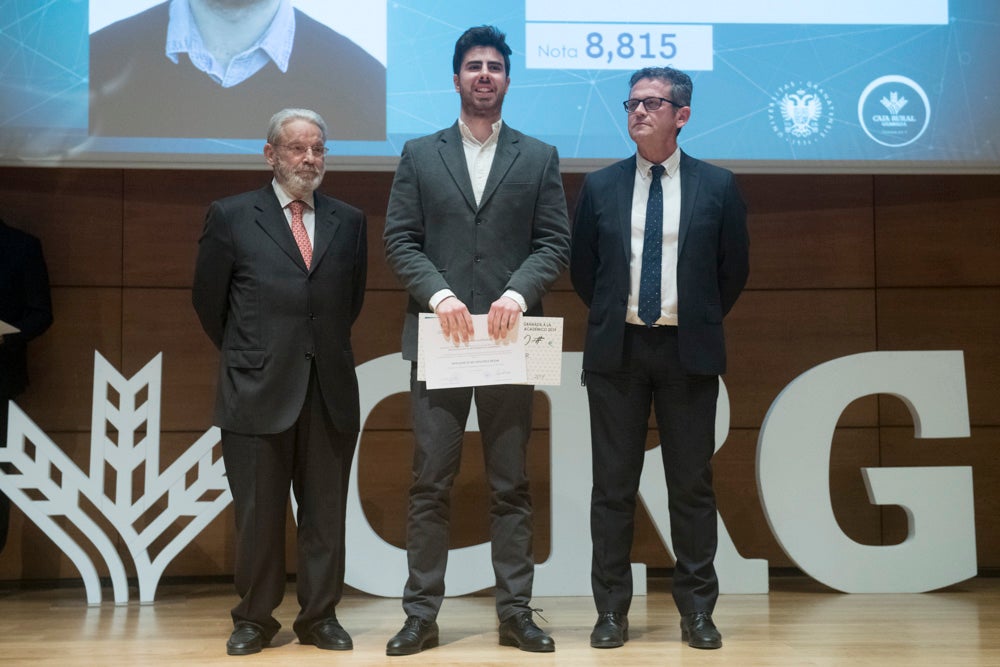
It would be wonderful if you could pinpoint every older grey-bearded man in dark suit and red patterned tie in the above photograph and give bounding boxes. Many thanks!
[193,109,367,655]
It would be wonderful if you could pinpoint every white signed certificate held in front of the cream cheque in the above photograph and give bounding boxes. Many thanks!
[417,313,527,389]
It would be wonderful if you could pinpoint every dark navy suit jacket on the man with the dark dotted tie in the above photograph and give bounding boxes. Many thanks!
[570,153,749,375]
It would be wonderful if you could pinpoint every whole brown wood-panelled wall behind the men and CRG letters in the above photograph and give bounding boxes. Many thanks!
[0,168,1000,579]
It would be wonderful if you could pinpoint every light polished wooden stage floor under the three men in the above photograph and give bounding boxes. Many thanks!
[0,577,1000,667]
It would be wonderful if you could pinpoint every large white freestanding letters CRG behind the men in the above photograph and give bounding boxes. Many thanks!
[346,351,977,597]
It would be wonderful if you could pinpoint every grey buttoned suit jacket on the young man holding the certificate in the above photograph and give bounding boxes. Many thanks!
[384,123,569,360]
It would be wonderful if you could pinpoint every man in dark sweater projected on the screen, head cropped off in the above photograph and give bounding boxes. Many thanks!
[90,0,386,141]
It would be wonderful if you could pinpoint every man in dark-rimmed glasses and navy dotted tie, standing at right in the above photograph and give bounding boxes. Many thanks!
[570,68,749,648]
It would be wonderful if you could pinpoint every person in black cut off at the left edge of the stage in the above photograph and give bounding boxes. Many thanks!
[0,220,52,551]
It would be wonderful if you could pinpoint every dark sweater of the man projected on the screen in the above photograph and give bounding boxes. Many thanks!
[90,2,385,141]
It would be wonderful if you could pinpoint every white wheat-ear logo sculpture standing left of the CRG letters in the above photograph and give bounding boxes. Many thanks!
[0,352,232,605]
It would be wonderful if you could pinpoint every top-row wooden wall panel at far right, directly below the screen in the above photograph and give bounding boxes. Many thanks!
[875,175,1000,287]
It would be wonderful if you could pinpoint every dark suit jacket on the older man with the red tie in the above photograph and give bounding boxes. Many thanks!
[192,184,367,434]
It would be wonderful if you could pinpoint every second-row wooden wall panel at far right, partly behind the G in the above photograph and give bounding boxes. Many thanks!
[878,288,1000,426]
